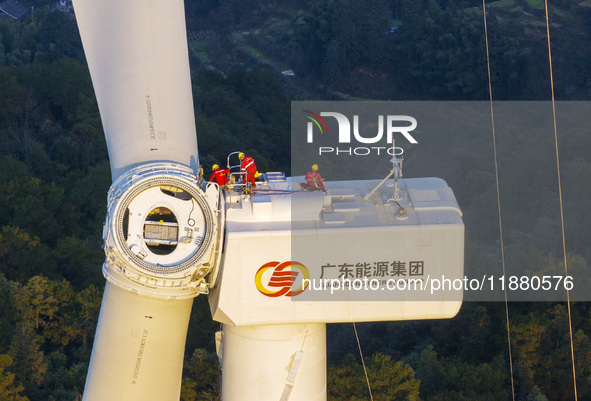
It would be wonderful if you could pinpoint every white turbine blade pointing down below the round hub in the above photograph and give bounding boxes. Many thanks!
[83,282,193,401]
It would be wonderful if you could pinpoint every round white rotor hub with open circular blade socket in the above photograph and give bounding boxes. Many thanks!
[103,163,223,299]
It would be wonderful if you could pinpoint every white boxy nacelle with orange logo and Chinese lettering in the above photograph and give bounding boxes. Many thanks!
[210,178,464,326]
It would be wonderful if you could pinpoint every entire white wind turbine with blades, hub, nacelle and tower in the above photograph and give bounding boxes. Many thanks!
[74,0,464,401]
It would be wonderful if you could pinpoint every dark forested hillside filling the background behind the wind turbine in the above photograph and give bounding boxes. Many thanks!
[0,0,591,401]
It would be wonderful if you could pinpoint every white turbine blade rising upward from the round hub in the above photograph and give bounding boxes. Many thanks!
[74,0,199,180]
